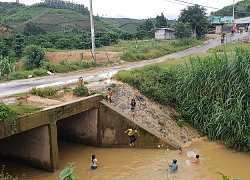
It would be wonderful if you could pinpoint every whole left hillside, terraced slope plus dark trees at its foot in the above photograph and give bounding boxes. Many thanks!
[0,0,133,53]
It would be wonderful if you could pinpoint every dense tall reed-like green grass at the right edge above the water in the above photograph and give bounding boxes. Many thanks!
[176,48,250,152]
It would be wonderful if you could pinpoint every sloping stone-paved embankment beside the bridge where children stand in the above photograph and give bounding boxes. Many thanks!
[95,83,198,147]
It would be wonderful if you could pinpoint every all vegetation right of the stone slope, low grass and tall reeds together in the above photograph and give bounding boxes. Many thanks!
[115,43,250,152]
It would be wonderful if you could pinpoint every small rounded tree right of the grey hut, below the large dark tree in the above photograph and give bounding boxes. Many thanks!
[174,21,192,39]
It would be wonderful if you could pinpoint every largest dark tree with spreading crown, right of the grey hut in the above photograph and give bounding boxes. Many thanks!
[178,4,209,38]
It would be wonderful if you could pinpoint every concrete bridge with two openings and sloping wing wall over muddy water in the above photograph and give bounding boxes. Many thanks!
[0,94,178,172]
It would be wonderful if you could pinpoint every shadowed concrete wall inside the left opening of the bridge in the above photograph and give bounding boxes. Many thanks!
[0,125,58,171]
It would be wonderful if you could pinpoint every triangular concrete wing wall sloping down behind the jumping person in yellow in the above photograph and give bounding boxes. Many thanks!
[98,101,177,149]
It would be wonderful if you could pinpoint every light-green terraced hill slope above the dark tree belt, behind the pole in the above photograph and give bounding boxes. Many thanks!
[0,0,127,34]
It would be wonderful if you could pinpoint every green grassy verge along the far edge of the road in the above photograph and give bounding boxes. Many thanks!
[0,39,205,81]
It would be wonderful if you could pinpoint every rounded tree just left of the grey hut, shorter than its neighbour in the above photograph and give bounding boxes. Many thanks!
[136,19,154,39]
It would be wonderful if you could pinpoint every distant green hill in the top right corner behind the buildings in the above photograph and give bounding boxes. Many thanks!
[211,0,250,19]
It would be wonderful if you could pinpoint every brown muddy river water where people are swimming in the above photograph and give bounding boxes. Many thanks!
[1,138,250,180]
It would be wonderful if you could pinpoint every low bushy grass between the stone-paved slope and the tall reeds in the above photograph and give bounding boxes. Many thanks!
[114,64,176,106]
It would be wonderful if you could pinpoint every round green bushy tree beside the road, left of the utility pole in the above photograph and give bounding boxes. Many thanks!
[24,45,46,70]
